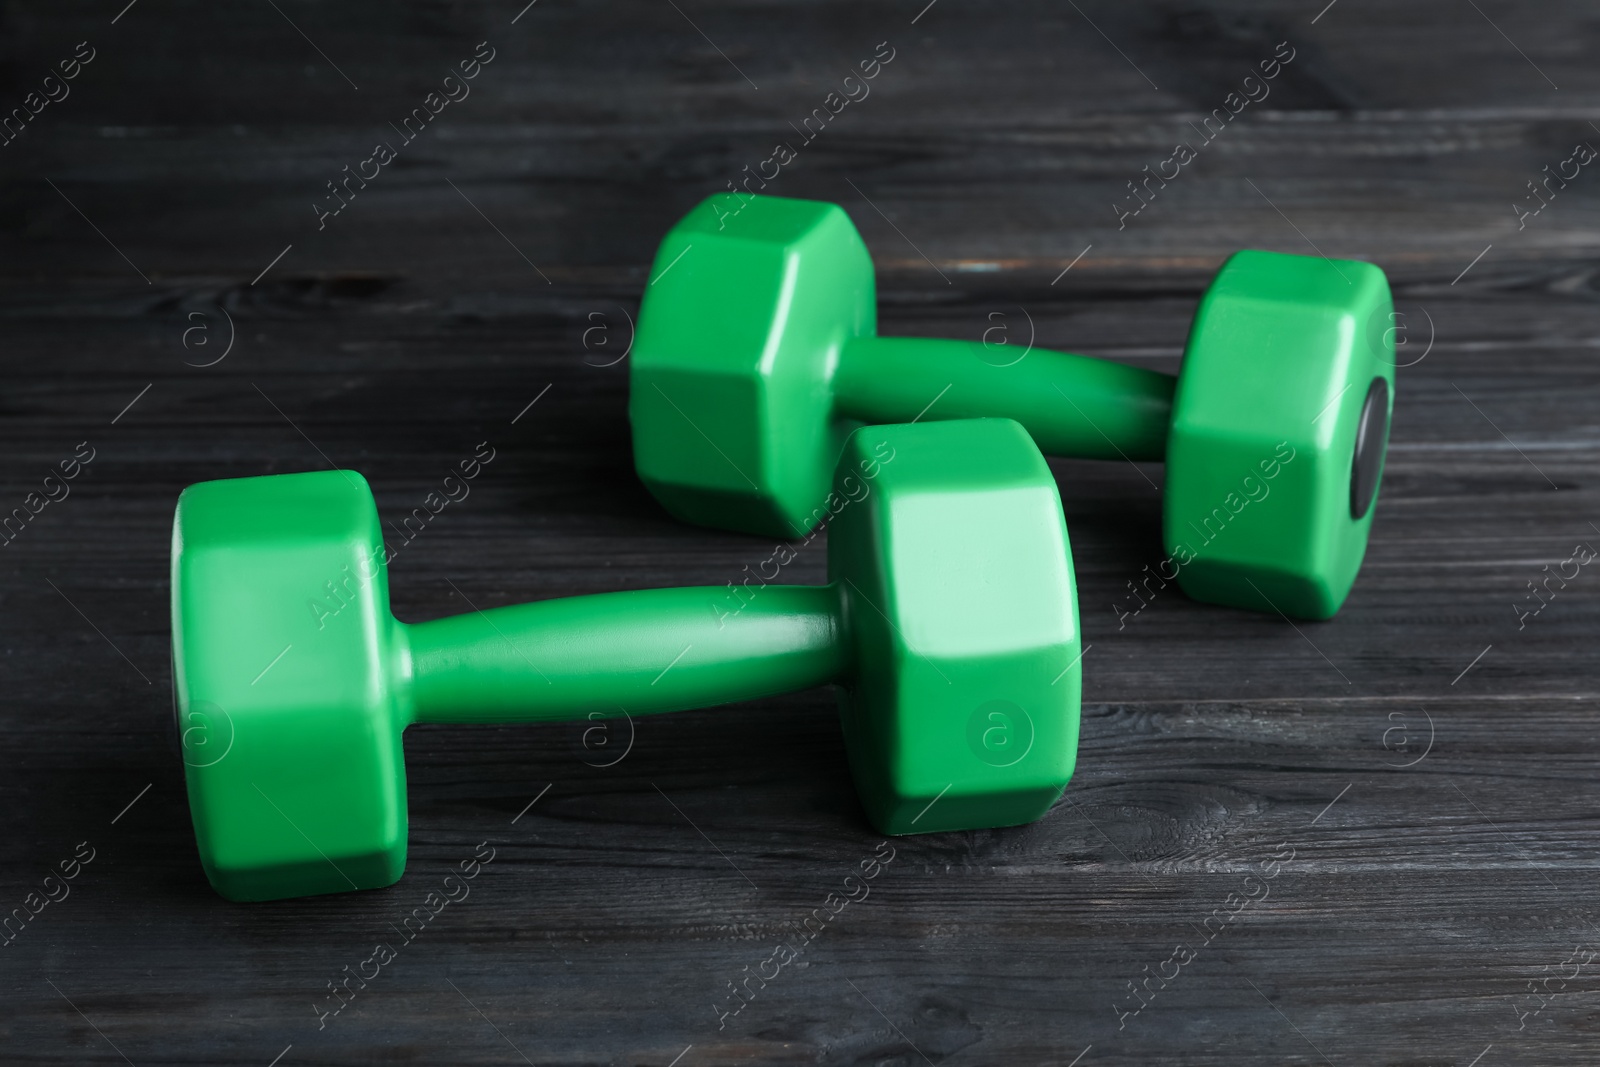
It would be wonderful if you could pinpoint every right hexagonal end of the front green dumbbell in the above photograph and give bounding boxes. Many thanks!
[829,419,1082,833]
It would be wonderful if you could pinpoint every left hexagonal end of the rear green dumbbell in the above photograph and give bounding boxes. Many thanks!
[629,194,877,537]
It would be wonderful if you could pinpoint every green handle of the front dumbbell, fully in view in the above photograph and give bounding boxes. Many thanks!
[398,585,851,723]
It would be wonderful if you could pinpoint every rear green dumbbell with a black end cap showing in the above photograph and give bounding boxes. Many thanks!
[629,194,1394,619]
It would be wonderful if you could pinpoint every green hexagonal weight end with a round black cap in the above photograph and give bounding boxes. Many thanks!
[1163,251,1394,619]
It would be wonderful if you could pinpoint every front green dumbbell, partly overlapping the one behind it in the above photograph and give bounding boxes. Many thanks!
[173,419,1080,901]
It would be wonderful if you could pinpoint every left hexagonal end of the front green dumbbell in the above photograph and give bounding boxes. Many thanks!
[173,470,406,901]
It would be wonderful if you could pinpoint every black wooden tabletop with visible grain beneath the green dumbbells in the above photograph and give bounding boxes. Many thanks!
[0,0,1600,1067]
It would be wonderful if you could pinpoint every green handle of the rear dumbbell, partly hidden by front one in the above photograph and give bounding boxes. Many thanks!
[834,338,1178,461]
